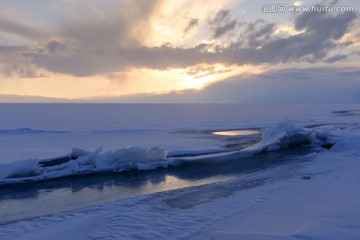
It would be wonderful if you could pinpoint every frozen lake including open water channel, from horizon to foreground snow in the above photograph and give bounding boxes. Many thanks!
[0,104,357,224]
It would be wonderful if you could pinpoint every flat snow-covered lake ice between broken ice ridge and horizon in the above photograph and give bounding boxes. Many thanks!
[0,104,358,163]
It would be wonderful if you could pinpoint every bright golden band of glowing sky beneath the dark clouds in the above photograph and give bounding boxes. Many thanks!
[0,64,265,99]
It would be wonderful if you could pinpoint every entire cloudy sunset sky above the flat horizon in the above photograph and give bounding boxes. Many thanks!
[0,0,360,103]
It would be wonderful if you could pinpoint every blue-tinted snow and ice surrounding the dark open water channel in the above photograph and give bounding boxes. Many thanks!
[0,105,360,239]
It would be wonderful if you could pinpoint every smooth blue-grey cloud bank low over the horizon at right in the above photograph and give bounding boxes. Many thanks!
[96,68,360,103]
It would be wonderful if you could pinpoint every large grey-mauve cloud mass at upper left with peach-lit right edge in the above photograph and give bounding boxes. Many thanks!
[0,0,161,76]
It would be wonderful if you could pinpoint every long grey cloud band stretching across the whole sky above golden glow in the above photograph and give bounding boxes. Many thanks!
[0,0,356,76]
